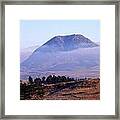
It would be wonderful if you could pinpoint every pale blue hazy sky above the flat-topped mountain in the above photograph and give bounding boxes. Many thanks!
[20,20,100,49]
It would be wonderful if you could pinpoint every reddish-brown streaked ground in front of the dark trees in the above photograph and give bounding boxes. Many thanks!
[27,79,100,100]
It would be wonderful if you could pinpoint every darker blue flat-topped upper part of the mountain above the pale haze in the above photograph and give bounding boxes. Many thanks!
[35,34,98,52]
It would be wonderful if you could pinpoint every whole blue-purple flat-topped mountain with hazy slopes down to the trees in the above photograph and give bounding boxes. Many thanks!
[20,34,99,79]
